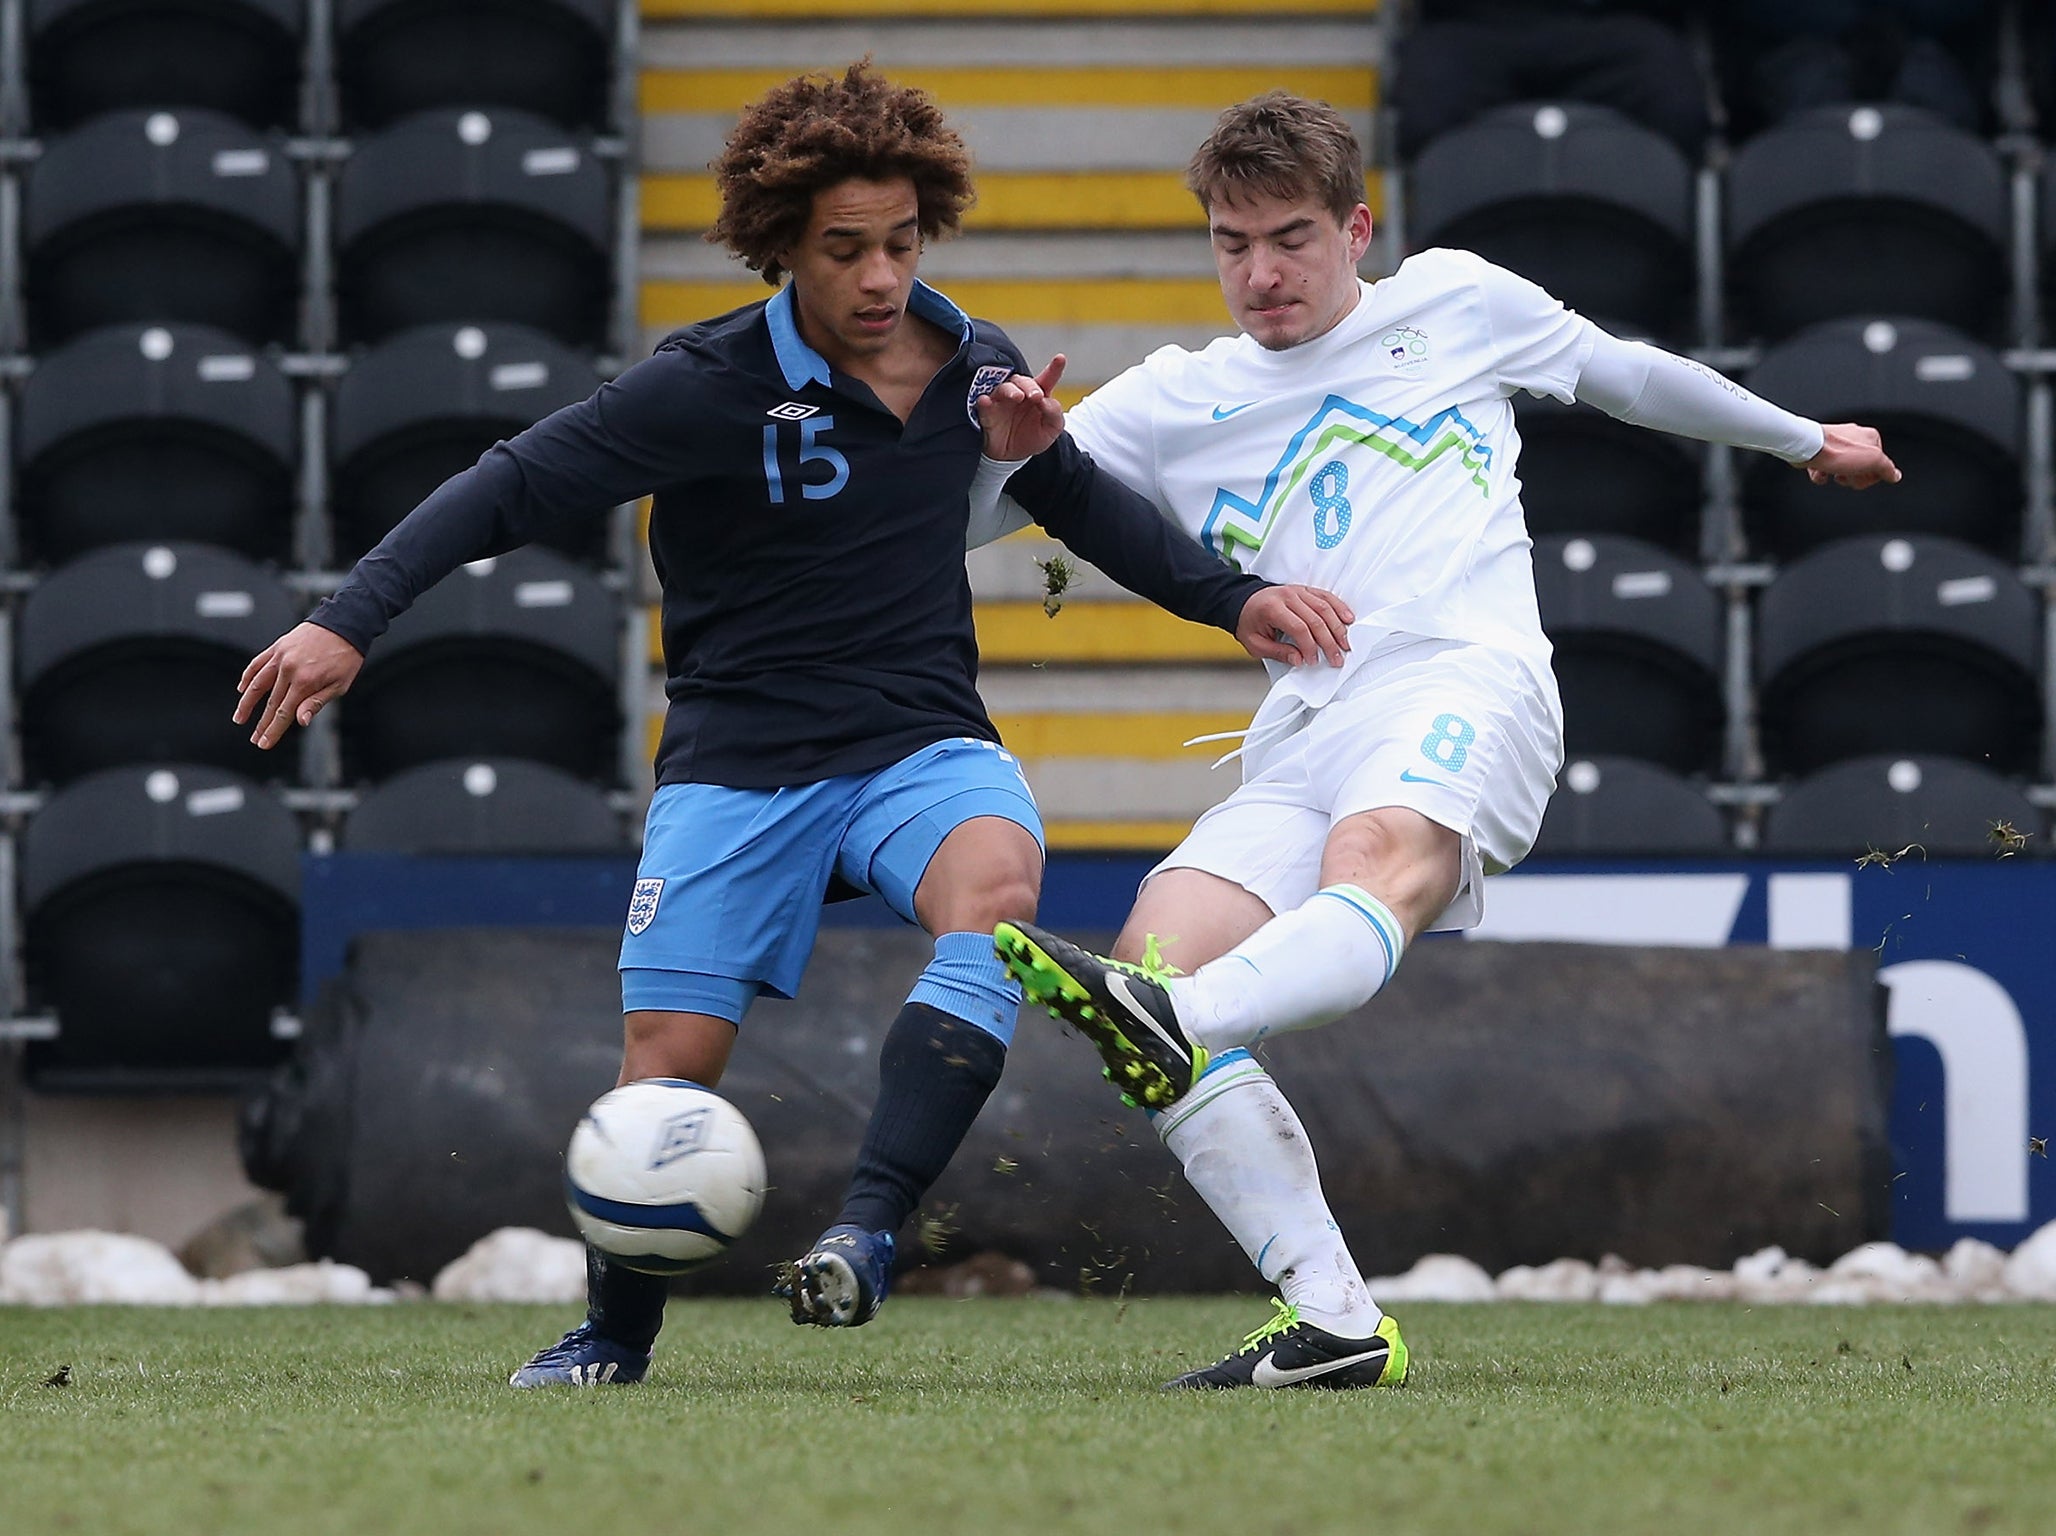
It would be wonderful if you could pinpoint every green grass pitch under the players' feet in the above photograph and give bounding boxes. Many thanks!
[0,1297,2056,1536]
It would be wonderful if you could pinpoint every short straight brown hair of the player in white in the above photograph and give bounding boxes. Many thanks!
[1184,90,1363,224]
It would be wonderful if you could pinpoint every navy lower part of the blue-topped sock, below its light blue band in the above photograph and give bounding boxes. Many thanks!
[837,1001,1012,1232]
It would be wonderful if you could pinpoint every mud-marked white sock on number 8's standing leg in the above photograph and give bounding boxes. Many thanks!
[1153,1051,1384,1339]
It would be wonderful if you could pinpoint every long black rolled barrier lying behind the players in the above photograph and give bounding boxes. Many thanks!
[243,929,1892,1306]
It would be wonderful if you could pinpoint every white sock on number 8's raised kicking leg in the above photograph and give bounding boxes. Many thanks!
[1168,886,1406,1051]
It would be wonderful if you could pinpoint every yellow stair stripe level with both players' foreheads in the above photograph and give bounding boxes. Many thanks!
[641,171,1386,232]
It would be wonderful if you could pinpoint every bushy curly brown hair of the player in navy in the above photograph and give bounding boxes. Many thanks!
[707,58,977,284]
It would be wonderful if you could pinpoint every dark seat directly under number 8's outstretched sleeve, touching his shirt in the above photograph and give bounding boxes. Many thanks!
[1513,370,1704,559]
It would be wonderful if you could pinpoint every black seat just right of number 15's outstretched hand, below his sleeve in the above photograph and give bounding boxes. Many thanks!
[341,549,621,781]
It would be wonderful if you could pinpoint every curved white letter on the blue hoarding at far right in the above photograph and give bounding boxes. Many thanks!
[1877,960,2027,1221]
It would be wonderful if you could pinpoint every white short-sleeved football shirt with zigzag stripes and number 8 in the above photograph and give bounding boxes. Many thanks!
[1067,251,1593,705]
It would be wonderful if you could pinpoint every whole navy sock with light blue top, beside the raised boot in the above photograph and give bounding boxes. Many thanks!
[837,934,1020,1232]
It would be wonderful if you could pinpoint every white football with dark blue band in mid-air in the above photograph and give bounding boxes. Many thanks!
[563,1077,765,1275]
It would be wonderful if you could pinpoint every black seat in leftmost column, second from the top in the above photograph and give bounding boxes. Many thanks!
[25,111,300,348]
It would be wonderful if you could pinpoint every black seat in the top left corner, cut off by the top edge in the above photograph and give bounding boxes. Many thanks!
[29,0,306,132]
